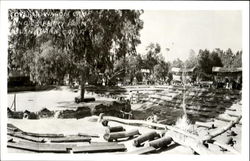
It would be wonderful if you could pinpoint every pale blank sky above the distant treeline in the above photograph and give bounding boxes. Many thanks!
[137,10,242,61]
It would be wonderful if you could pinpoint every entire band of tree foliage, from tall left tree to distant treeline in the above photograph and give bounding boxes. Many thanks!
[8,9,242,89]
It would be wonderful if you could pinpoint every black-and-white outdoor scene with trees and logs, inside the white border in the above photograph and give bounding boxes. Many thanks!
[1,2,249,160]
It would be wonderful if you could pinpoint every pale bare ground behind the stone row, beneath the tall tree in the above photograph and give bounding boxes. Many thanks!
[8,86,114,112]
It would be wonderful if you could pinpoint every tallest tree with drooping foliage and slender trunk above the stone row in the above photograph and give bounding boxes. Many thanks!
[9,9,143,99]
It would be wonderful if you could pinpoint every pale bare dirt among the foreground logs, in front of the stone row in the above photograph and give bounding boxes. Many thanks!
[8,100,242,155]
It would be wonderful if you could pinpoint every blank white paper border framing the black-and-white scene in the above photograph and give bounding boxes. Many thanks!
[0,1,249,161]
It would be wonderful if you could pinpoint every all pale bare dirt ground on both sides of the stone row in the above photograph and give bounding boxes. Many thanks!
[8,87,242,154]
